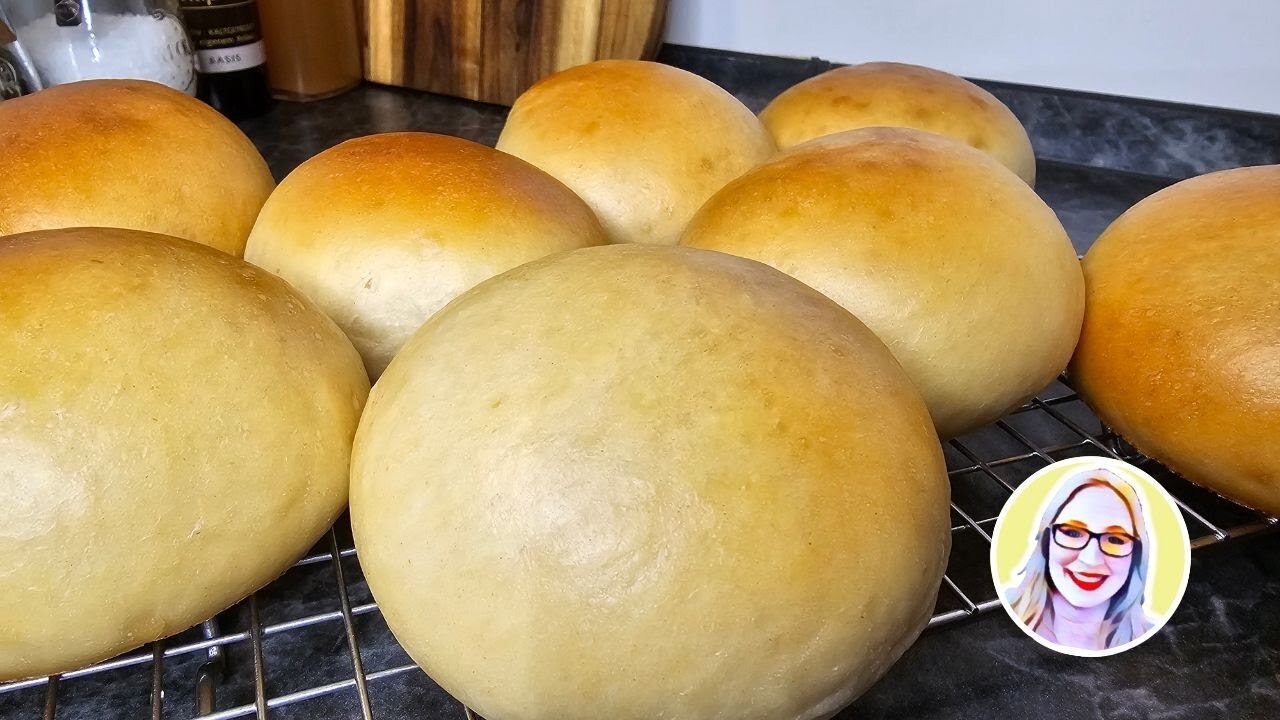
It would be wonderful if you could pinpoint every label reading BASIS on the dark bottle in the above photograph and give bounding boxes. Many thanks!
[178,0,266,73]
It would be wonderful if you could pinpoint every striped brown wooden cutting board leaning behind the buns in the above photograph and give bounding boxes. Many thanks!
[365,0,667,105]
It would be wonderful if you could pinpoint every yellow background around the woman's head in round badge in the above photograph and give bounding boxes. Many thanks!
[992,457,1190,619]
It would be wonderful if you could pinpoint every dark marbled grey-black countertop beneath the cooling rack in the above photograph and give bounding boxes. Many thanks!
[0,46,1280,720]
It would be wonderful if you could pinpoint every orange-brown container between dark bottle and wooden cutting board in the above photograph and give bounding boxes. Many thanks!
[259,0,362,100]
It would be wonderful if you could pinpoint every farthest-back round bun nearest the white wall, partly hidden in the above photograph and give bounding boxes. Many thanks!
[760,63,1036,184]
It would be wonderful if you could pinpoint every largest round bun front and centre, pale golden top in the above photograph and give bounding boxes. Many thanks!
[351,246,950,720]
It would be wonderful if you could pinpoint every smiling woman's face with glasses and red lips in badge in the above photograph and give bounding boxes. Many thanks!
[1048,487,1135,607]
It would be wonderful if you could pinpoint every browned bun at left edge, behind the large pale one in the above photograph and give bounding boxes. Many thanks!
[0,79,275,256]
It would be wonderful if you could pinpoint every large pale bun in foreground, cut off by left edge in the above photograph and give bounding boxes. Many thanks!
[0,228,369,680]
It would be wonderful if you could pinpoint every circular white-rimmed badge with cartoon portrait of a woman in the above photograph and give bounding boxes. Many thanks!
[991,457,1190,657]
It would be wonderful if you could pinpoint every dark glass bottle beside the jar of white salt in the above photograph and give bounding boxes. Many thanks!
[178,0,271,120]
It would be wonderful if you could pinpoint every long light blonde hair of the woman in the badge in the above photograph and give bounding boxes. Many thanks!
[1010,469,1152,648]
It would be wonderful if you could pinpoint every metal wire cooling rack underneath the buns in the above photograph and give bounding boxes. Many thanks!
[0,383,1277,720]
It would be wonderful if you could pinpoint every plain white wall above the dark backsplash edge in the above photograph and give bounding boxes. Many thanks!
[667,0,1280,114]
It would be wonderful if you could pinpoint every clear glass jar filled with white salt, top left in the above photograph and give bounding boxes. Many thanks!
[0,0,196,95]
